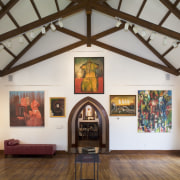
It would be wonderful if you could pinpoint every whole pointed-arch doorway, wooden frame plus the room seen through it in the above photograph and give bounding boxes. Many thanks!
[68,97,109,153]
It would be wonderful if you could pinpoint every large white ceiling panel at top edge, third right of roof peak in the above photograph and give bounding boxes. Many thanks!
[140,0,168,24]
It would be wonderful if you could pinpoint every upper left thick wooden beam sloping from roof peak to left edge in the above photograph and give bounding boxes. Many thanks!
[0,3,84,42]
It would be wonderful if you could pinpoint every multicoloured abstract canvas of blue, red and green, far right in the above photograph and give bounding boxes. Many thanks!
[138,90,172,132]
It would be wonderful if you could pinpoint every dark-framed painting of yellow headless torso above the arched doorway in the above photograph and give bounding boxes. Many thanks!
[74,57,104,94]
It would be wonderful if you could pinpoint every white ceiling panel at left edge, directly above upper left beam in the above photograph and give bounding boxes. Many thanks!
[0,15,16,34]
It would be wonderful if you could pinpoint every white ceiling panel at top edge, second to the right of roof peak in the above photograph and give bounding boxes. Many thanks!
[120,0,143,16]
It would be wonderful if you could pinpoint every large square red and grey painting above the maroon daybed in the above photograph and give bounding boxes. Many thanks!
[10,91,44,127]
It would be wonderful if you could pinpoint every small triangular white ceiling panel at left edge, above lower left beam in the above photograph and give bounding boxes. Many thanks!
[0,49,13,70]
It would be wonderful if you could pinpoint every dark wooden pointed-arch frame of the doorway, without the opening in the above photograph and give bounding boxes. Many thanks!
[68,97,109,153]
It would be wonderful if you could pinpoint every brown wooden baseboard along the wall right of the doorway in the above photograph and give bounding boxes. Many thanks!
[109,150,180,155]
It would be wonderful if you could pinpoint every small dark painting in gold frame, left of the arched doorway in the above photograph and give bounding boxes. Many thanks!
[50,97,66,117]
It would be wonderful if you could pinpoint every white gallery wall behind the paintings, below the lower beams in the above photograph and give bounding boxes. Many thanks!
[0,43,180,150]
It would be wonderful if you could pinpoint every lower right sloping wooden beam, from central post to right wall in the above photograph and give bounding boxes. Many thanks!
[92,41,178,76]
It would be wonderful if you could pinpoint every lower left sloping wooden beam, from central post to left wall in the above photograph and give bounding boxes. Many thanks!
[0,41,86,77]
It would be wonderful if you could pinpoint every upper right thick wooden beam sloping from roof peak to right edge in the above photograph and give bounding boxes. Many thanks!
[92,3,180,40]
